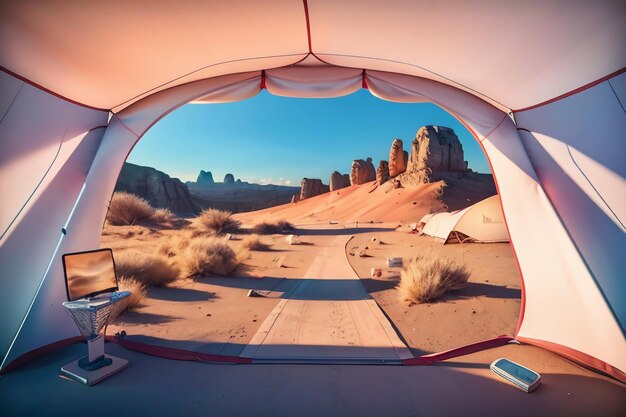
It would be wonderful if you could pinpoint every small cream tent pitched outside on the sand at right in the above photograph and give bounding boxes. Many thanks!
[420,195,509,243]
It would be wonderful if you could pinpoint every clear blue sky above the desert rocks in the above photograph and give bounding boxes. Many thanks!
[128,90,490,185]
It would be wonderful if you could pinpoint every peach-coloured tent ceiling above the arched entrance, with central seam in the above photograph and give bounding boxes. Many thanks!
[0,0,626,109]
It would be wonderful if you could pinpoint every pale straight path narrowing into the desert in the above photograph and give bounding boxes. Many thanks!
[241,235,412,363]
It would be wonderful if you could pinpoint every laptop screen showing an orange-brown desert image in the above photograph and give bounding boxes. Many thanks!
[63,249,117,301]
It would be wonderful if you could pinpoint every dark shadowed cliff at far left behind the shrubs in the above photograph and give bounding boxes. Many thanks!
[115,162,197,215]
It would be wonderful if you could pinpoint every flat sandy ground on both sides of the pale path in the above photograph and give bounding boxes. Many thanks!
[101,223,521,355]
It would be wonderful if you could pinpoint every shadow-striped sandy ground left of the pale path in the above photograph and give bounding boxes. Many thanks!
[100,225,329,355]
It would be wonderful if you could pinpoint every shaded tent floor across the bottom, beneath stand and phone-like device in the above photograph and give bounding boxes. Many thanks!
[0,343,626,416]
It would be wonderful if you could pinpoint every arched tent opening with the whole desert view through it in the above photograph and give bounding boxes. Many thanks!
[100,90,521,363]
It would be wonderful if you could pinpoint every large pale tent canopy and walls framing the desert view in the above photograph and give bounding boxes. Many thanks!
[0,0,626,379]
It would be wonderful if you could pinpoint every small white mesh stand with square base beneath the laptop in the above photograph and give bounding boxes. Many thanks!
[61,291,131,385]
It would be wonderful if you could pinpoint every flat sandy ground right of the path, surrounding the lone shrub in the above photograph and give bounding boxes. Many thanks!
[346,225,521,354]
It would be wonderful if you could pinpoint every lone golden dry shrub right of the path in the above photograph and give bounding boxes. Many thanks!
[398,257,470,303]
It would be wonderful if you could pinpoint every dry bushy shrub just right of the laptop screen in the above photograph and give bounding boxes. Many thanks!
[115,250,180,287]
